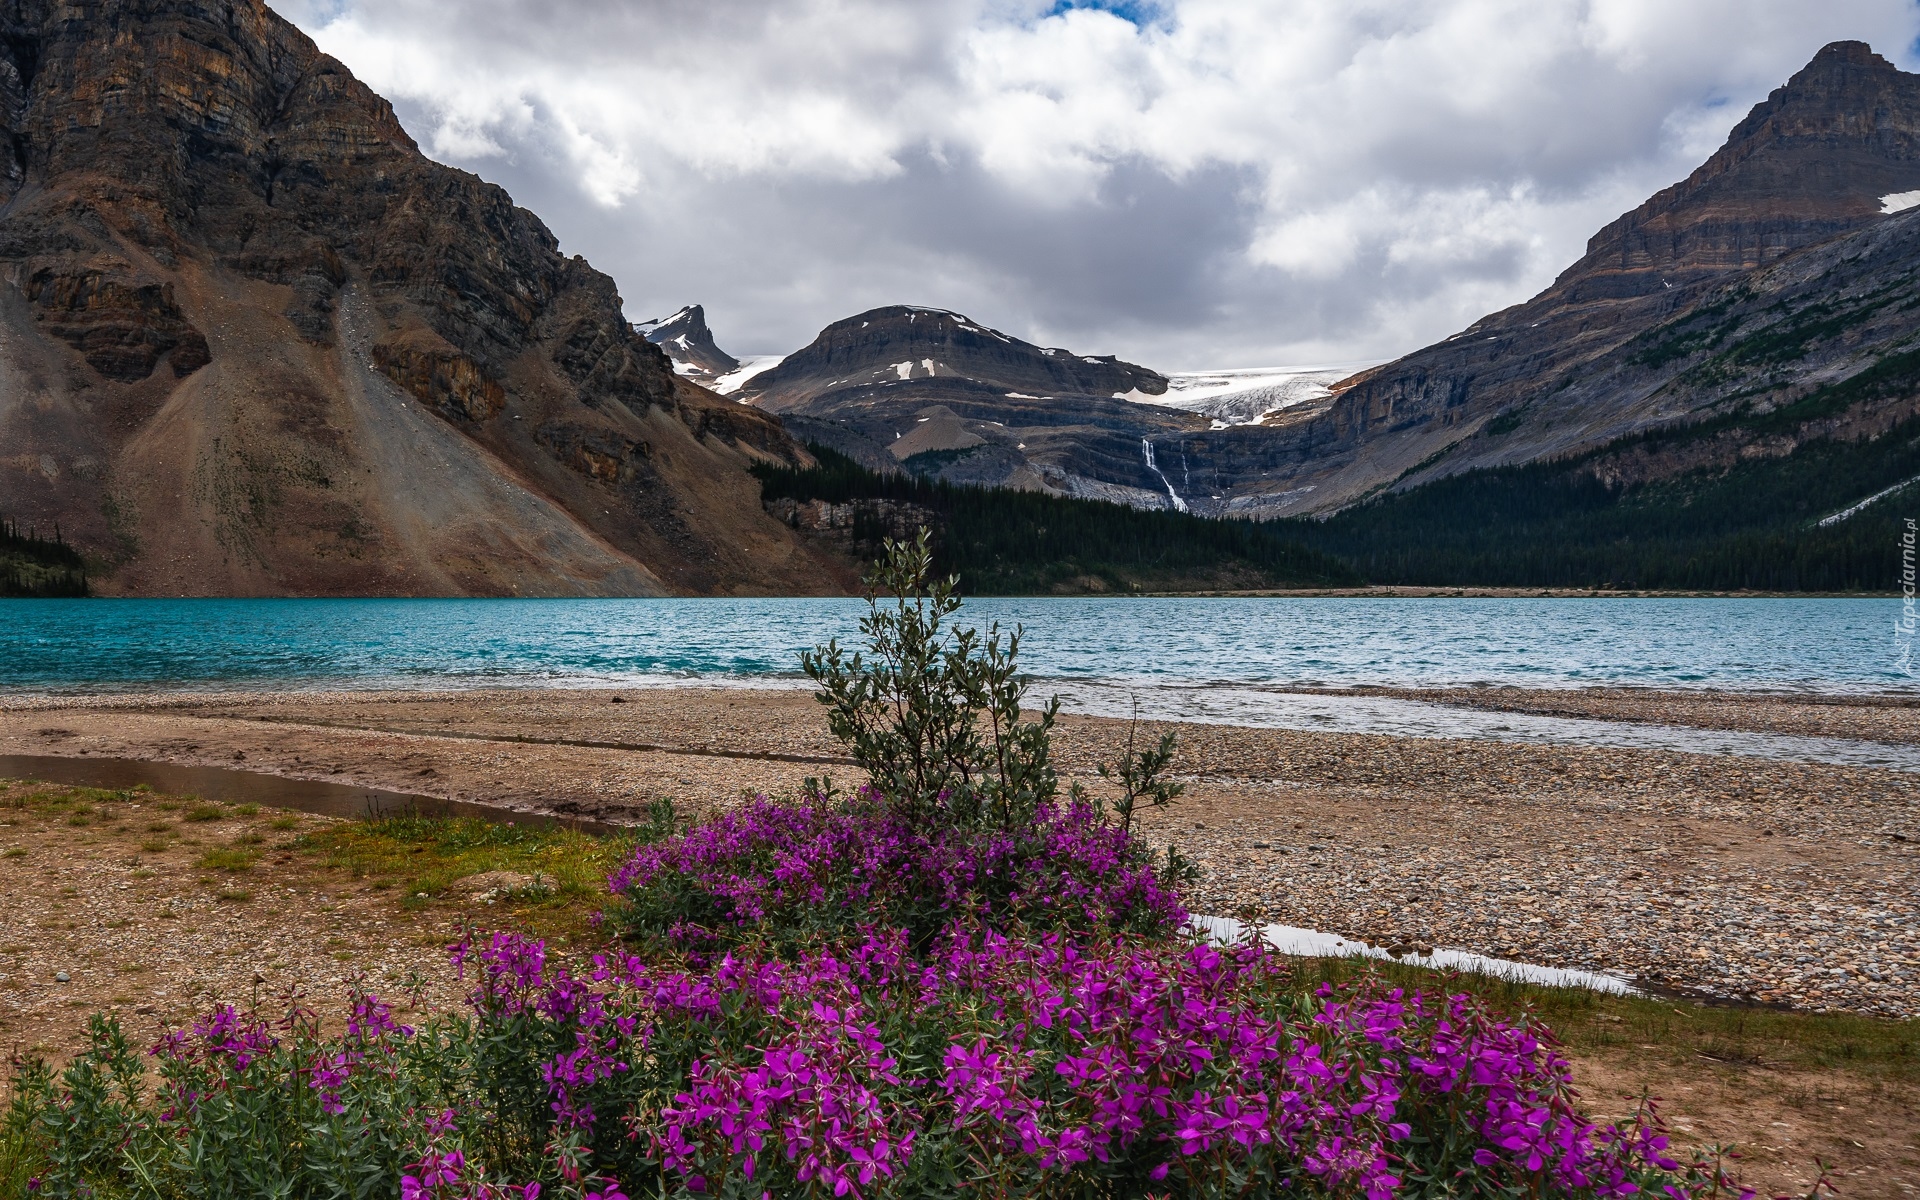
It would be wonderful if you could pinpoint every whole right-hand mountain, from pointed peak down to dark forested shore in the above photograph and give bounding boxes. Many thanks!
[1275,42,1920,591]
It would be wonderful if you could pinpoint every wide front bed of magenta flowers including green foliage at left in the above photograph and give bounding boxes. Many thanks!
[11,906,1724,1200]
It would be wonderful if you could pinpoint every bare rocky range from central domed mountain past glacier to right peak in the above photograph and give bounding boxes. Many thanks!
[739,42,1920,533]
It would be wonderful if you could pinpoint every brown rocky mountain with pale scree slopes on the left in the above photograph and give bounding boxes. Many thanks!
[0,0,849,595]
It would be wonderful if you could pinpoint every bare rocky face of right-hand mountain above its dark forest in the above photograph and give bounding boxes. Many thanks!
[1190,42,1920,516]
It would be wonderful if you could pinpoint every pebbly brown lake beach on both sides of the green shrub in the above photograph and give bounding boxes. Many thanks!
[0,687,1920,1018]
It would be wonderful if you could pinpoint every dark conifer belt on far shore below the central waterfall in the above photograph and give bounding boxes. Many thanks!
[753,445,1359,595]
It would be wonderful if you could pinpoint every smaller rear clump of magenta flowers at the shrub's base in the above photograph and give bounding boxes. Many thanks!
[609,791,1187,945]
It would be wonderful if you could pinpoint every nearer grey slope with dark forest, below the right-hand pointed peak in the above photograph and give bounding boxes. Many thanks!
[1279,192,1920,591]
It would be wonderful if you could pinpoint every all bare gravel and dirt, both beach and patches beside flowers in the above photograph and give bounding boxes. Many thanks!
[0,689,1920,1196]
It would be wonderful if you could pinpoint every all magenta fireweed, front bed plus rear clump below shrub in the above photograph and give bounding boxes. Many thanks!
[30,787,1724,1200]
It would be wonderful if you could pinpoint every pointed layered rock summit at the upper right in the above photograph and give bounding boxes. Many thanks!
[1549,42,1920,300]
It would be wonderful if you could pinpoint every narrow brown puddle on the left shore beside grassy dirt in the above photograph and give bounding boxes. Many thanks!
[0,755,614,833]
